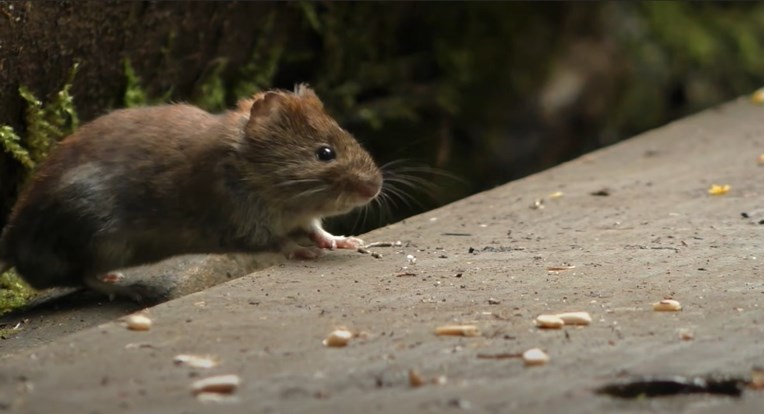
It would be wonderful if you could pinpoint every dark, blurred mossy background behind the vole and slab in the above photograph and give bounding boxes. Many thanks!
[0,1,763,232]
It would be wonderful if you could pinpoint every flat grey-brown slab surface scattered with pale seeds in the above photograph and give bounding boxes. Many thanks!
[0,95,763,413]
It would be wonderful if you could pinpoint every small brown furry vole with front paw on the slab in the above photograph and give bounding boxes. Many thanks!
[0,85,382,296]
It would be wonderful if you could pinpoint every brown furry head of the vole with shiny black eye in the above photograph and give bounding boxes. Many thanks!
[231,85,382,217]
